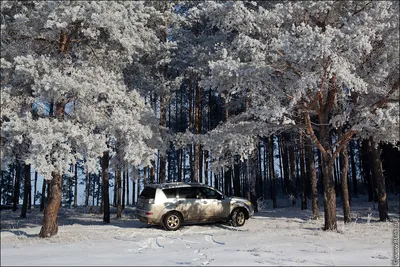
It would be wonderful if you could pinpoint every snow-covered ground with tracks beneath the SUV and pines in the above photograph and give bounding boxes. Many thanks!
[1,195,399,266]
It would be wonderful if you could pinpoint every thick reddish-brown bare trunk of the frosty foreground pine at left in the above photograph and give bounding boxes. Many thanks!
[39,171,62,238]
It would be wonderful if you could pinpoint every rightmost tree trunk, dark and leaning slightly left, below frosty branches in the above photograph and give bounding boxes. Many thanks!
[370,137,389,222]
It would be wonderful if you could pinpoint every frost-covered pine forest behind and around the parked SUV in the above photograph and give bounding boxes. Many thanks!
[0,1,400,237]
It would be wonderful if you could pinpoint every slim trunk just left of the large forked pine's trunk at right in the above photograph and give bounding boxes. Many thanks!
[306,139,319,220]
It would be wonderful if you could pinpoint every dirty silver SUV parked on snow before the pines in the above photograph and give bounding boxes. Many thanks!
[136,183,254,231]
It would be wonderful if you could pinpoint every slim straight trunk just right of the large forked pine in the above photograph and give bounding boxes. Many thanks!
[340,142,351,223]
